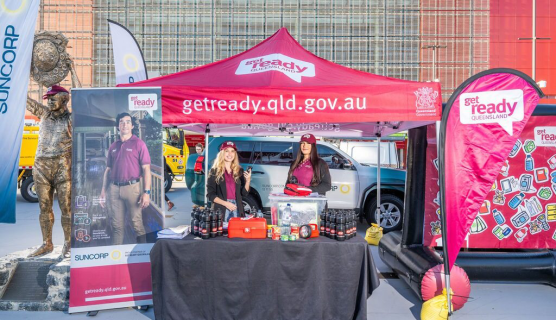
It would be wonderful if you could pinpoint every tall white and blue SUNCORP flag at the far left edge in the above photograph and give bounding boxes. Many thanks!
[0,0,39,223]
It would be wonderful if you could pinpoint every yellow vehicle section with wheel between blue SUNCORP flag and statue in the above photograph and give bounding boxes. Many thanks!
[17,126,39,202]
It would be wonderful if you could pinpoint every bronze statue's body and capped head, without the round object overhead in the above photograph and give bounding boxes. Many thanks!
[27,85,72,258]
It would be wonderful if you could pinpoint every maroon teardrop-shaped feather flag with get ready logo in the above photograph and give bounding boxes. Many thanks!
[440,69,542,268]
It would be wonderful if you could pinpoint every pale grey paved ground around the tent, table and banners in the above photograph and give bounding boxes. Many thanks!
[0,183,556,320]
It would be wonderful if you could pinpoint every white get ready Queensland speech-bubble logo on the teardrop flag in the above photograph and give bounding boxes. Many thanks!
[459,89,524,135]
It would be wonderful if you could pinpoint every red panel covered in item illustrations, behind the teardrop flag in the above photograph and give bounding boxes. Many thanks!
[424,116,556,249]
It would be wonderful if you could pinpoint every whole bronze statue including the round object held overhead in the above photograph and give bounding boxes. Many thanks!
[27,32,81,258]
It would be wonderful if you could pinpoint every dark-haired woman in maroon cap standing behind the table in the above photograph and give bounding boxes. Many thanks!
[286,133,332,195]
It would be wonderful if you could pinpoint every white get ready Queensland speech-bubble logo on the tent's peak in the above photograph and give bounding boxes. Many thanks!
[236,53,315,82]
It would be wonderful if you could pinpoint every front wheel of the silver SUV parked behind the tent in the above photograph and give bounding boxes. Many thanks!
[365,194,403,233]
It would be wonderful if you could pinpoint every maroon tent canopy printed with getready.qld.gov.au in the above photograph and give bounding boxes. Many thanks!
[124,28,442,137]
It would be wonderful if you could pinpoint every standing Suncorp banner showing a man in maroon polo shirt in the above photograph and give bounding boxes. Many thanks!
[69,88,164,313]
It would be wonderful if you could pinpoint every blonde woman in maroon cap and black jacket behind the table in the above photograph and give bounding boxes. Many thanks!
[207,141,251,222]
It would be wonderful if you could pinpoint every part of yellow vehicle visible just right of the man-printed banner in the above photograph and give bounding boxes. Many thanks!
[162,128,189,192]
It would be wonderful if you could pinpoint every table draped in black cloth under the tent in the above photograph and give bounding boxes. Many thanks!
[151,235,379,320]
